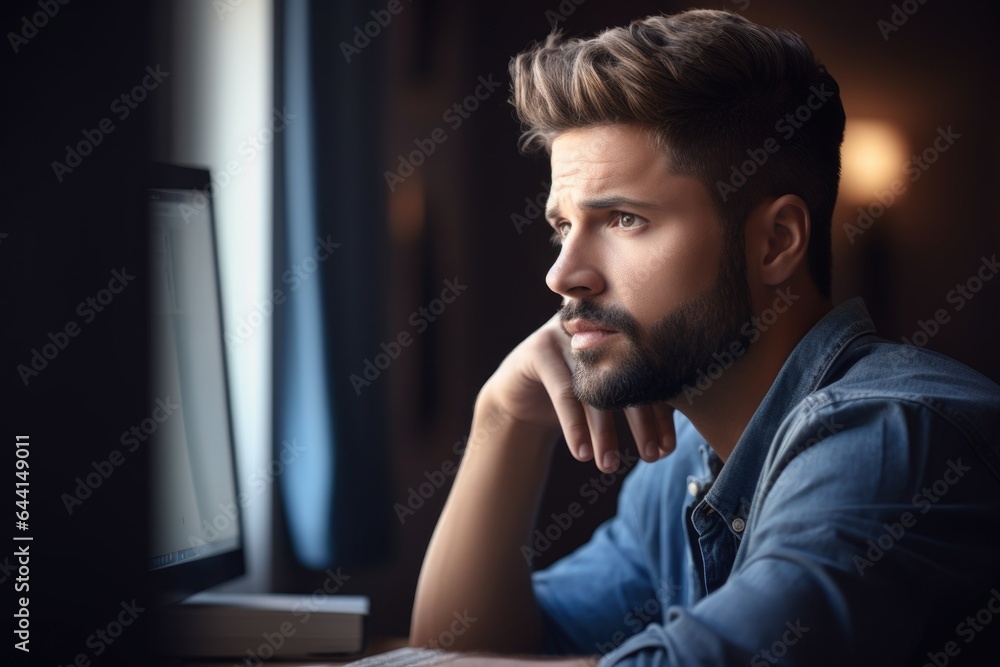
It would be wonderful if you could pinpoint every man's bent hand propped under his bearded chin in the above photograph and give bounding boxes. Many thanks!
[480,313,677,472]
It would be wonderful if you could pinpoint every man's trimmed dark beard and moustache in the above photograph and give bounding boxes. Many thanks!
[559,247,753,410]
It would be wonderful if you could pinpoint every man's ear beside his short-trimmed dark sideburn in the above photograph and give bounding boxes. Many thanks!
[747,195,811,285]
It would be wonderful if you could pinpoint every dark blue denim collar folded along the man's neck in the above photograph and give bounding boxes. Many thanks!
[705,297,875,533]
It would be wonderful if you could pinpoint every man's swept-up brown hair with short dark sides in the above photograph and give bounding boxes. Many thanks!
[510,10,844,298]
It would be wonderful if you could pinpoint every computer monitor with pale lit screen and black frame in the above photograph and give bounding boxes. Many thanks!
[148,164,245,604]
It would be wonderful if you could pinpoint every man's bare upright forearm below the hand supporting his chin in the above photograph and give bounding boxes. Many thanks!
[410,392,556,653]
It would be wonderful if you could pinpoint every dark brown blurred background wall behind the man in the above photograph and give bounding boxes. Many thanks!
[274,0,1000,634]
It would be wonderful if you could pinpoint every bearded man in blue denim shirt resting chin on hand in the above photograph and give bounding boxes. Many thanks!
[411,11,1000,665]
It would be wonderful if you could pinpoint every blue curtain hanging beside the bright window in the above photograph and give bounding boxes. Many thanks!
[273,0,392,569]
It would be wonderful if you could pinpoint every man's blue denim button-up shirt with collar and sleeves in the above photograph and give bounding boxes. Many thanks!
[534,299,1000,667]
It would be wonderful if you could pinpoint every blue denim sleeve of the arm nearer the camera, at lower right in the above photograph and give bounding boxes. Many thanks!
[600,401,1000,667]
